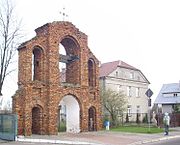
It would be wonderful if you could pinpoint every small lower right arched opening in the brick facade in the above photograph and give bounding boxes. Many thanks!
[88,107,97,131]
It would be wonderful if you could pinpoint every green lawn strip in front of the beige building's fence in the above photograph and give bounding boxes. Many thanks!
[110,126,163,134]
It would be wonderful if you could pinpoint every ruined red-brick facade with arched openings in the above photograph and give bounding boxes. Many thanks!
[13,22,102,135]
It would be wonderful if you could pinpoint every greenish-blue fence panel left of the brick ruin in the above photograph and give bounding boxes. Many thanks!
[0,114,17,141]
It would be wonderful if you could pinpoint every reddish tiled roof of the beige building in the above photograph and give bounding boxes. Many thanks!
[99,60,138,77]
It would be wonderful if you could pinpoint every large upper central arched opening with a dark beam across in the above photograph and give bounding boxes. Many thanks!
[59,36,80,84]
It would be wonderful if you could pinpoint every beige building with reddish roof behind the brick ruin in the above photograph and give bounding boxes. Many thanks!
[100,60,150,115]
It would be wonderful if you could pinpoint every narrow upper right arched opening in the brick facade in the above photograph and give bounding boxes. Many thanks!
[88,59,96,87]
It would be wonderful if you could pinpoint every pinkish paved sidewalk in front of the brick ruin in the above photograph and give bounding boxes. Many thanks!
[17,128,180,145]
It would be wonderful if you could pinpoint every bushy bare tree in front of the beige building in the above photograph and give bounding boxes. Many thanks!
[100,89,127,126]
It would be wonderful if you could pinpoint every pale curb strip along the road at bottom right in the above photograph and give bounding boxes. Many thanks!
[128,135,180,145]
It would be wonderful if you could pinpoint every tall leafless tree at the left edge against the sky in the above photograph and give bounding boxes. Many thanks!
[0,0,21,95]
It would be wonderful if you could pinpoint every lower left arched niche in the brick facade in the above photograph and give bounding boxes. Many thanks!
[31,106,42,134]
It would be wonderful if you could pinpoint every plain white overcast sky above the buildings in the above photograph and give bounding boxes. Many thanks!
[4,0,180,106]
